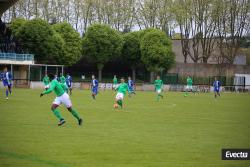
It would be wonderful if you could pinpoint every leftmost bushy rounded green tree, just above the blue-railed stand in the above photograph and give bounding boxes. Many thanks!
[10,19,65,63]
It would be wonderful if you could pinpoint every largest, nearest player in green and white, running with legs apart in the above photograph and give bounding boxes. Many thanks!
[40,74,83,126]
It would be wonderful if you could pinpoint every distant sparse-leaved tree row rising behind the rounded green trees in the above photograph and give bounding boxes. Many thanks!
[3,0,176,33]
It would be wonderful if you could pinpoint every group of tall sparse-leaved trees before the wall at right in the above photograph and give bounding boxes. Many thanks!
[172,0,250,64]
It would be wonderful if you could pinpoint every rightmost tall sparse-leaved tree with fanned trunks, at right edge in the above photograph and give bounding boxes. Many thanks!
[217,0,250,64]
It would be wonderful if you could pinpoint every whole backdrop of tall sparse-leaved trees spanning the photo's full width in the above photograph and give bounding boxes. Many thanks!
[2,0,250,63]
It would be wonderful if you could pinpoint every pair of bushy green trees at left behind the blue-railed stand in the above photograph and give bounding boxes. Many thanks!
[10,19,82,65]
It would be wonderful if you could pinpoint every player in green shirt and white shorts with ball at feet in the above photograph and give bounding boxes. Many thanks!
[114,78,129,108]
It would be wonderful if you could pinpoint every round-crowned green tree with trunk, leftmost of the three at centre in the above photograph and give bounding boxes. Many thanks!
[83,24,123,81]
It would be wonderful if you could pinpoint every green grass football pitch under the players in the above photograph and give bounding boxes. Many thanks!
[0,89,250,167]
